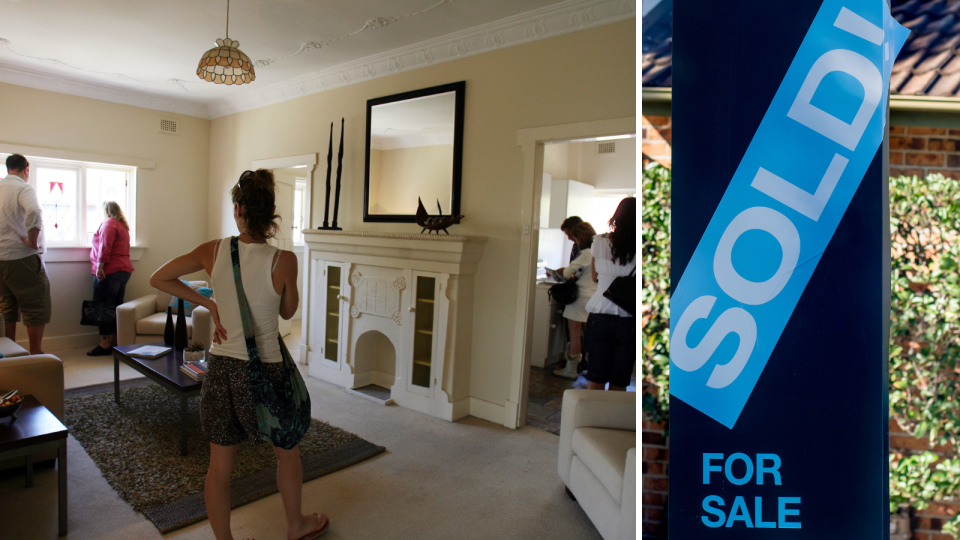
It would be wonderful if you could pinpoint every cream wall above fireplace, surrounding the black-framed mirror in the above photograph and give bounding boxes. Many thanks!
[208,19,636,405]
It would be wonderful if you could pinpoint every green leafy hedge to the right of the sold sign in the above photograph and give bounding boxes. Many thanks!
[890,174,960,534]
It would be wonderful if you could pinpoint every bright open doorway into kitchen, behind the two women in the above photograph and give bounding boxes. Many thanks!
[526,135,637,435]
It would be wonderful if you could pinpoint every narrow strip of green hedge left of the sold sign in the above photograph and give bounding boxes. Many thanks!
[640,163,670,424]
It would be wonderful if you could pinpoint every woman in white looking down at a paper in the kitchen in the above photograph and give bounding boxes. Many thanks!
[553,221,597,379]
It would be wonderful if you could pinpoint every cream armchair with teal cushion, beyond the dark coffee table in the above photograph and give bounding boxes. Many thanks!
[117,281,213,347]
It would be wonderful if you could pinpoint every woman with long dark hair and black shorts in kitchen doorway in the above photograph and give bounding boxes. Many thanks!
[585,197,637,390]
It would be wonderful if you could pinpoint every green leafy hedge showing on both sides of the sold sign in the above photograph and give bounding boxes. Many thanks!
[641,170,960,534]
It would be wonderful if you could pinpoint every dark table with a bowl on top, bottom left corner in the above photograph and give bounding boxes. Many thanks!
[0,395,67,536]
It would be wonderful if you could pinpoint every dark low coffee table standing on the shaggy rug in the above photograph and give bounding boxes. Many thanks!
[113,341,203,456]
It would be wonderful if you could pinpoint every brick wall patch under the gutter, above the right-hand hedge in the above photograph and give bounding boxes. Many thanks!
[890,126,960,178]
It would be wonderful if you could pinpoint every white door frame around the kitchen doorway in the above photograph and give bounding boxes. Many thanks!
[503,116,637,429]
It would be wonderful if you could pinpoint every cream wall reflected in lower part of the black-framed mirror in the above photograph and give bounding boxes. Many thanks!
[370,148,453,214]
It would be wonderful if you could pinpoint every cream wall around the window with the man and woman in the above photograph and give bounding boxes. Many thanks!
[0,84,210,351]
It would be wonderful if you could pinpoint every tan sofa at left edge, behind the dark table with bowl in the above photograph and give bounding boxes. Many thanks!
[0,317,64,470]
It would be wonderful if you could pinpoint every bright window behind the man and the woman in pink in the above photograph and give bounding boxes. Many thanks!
[0,154,137,247]
